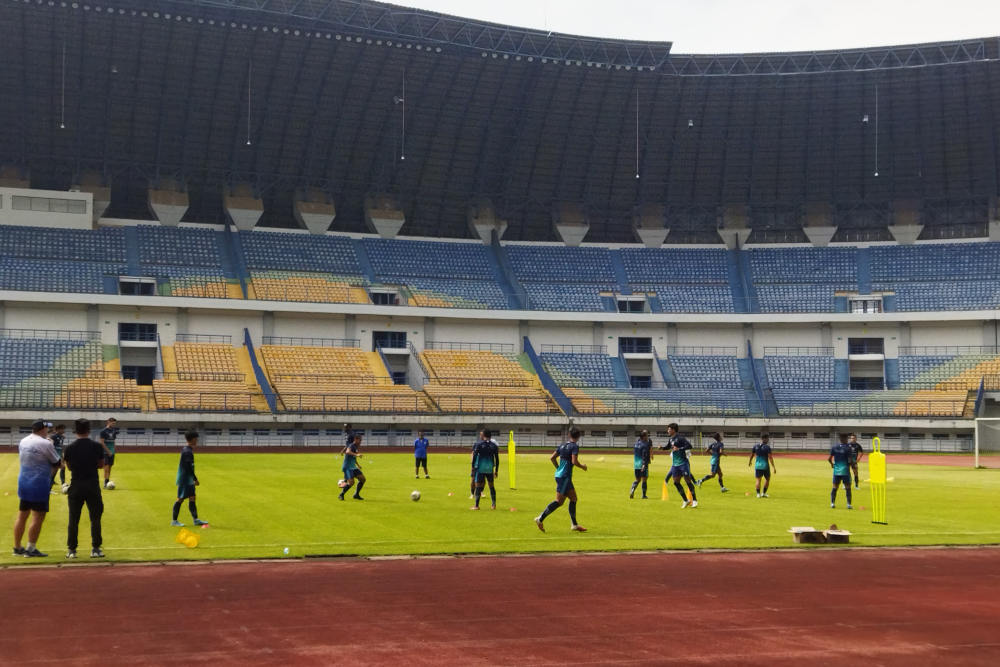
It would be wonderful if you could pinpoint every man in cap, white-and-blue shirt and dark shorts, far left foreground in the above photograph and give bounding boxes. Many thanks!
[14,420,59,558]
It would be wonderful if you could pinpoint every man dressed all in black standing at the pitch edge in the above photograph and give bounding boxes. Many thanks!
[63,419,104,558]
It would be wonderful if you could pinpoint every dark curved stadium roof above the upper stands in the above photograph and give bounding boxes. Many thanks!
[0,0,1000,242]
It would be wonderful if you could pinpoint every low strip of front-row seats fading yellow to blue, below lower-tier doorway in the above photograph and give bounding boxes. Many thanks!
[563,387,760,417]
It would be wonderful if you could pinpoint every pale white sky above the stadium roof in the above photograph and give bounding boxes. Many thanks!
[390,0,1000,53]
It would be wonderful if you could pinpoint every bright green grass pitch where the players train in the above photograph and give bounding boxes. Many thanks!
[0,452,1000,565]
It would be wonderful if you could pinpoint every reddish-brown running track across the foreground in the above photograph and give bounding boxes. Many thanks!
[0,548,1000,667]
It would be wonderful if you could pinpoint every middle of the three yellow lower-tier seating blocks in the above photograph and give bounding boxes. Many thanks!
[260,345,431,413]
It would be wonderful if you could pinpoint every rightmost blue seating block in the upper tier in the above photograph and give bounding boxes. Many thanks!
[871,243,1000,311]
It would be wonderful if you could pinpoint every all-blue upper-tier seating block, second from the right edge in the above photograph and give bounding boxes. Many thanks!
[747,248,858,313]
